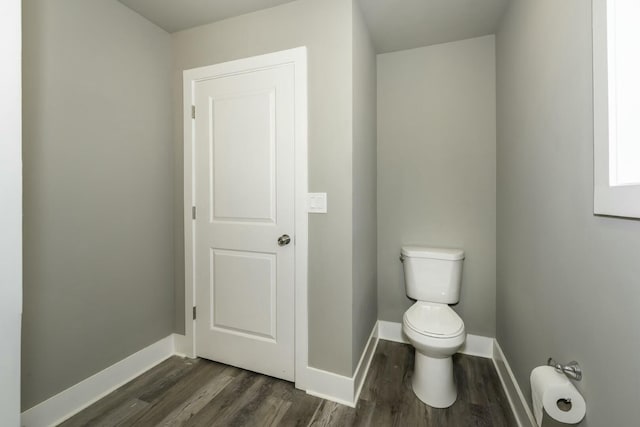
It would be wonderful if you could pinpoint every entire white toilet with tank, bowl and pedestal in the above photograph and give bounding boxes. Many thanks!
[400,246,466,408]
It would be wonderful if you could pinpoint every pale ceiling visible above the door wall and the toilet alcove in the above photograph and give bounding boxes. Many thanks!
[119,0,509,53]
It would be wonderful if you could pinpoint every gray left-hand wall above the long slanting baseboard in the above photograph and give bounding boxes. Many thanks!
[22,0,173,409]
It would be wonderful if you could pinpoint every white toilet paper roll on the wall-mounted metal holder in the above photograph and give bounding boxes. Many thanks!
[531,366,587,427]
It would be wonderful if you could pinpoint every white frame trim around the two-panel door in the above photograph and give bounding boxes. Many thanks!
[176,46,309,388]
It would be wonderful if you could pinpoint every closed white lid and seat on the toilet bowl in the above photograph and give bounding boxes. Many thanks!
[404,301,464,338]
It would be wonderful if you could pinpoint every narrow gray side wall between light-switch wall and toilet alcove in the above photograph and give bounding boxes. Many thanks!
[351,0,378,370]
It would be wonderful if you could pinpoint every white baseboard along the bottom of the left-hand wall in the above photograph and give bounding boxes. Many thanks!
[21,335,175,427]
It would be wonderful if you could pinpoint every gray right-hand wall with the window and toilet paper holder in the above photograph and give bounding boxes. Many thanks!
[497,0,640,427]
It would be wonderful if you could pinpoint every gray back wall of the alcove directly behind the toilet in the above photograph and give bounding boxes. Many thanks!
[378,36,496,337]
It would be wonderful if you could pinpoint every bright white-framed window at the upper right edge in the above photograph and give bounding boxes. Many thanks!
[593,0,640,218]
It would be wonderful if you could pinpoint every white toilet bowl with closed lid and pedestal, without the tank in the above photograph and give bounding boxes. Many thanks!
[402,301,466,408]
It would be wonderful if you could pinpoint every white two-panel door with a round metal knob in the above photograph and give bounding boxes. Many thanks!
[193,54,295,381]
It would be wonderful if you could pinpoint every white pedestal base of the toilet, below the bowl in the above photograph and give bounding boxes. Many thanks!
[411,351,458,408]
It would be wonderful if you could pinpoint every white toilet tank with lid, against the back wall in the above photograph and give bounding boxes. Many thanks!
[400,246,464,304]
